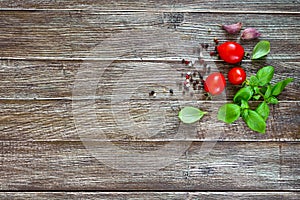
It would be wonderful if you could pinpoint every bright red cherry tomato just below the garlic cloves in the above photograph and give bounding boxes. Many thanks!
[217,42,245,64]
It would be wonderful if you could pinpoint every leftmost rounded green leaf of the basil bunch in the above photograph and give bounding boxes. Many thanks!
[218,103,240,124]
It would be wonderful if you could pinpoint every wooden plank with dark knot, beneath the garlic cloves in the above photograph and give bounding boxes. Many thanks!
[0,11,300,60]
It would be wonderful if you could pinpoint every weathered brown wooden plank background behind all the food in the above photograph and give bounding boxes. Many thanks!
[0,0,300,199]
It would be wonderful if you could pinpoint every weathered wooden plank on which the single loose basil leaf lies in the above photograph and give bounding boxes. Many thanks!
[0,99,300,141]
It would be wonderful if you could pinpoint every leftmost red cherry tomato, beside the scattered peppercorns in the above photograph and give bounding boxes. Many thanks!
[204,72,226,95]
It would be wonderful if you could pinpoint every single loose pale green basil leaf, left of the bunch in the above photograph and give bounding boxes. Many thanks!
[178,106,206,124]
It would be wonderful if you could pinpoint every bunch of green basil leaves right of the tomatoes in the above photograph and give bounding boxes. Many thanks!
[218,66,293,133]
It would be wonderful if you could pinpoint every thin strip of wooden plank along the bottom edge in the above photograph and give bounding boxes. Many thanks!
[0,192,299,200]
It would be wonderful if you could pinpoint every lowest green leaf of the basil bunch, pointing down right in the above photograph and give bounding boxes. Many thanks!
[243,110,266,133]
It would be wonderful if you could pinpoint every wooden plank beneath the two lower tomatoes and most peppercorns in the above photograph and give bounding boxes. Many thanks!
[0,60,300,101]
